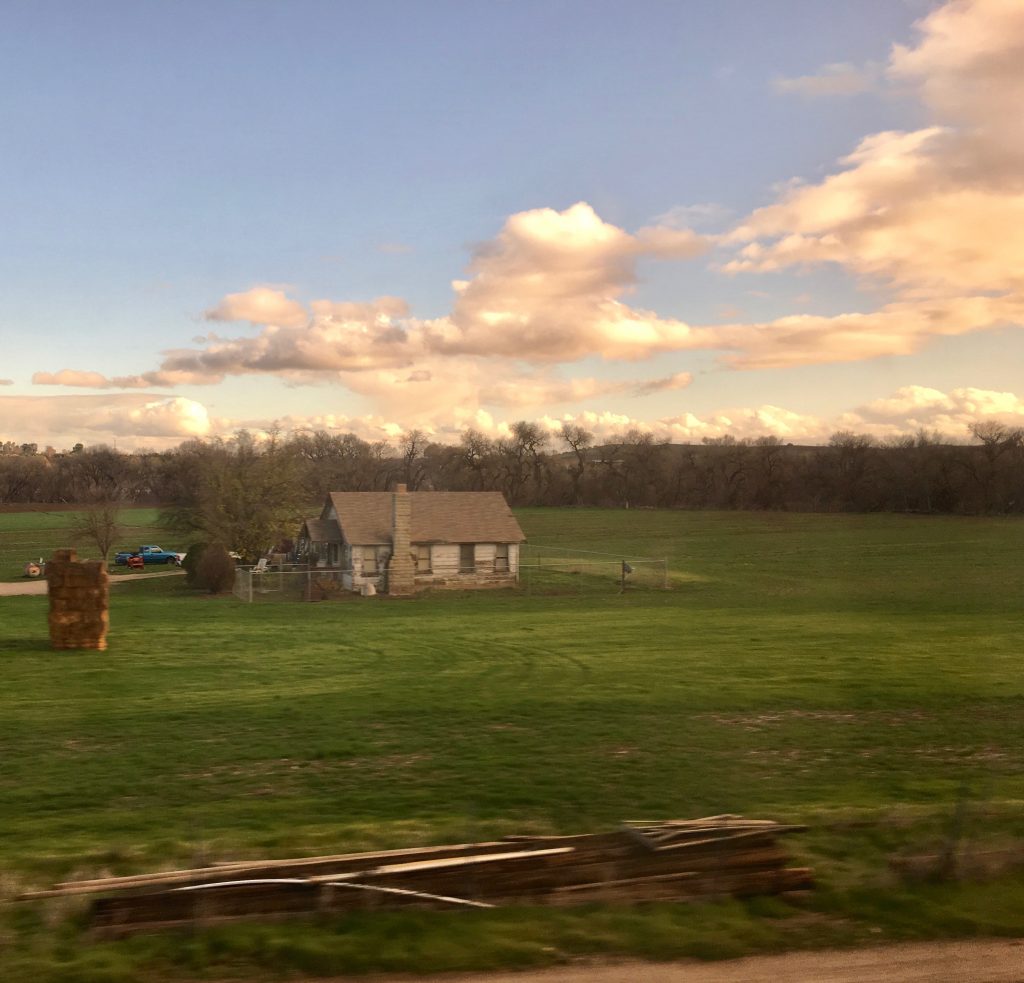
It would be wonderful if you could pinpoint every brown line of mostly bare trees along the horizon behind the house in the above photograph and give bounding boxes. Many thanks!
[0,421,1024,518]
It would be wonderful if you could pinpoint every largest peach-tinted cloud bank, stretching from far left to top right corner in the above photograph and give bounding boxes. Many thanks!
[28,0,1024,403]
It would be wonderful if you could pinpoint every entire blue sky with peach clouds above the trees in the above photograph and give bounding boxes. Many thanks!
[0,0,1024,450]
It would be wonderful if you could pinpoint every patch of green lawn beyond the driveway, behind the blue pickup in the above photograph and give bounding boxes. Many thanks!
[0,506,175,583]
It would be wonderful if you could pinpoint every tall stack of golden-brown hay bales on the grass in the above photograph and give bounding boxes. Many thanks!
[46,550,111,651]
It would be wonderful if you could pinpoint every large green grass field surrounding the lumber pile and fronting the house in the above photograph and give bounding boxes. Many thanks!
[0,510,1024,981]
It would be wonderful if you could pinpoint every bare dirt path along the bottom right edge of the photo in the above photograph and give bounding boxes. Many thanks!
[350,939,1024,983]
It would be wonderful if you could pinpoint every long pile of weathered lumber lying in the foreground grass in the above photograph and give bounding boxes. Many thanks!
[23,816,812,935]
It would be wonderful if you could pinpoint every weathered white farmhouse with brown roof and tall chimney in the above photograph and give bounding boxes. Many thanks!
[298,484,525,595]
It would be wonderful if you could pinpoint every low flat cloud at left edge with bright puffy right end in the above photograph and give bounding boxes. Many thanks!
[0,393,214,448]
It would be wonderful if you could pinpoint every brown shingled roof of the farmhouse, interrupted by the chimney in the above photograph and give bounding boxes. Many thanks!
[325,492,526,546]
